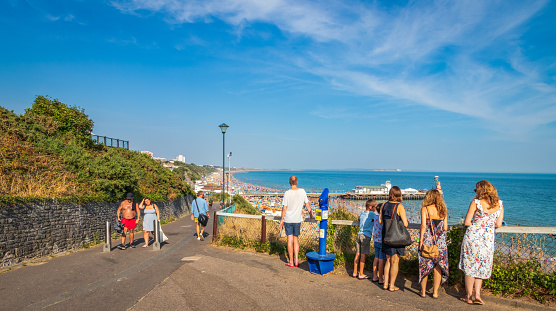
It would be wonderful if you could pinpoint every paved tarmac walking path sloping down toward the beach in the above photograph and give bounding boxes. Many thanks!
[0,205,552,311]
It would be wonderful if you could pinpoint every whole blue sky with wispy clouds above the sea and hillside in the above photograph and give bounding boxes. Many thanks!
[0,0,556,173]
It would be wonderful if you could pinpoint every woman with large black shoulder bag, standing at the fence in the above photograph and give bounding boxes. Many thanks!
[379,186,408,292]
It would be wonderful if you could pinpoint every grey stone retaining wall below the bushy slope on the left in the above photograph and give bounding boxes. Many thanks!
[0,196,193,267]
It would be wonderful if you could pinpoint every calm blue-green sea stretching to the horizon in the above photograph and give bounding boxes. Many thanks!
[234,171,556,226]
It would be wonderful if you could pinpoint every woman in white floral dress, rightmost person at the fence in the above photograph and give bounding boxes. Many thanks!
[459,180,504,305]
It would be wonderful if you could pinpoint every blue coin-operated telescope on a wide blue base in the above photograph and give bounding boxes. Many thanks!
[307,188,336,275]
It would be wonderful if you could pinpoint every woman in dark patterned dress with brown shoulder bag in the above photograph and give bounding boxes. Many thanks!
[419,189,448,299]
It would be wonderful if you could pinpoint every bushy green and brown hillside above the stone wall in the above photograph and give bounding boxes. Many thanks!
[0,96,192,202]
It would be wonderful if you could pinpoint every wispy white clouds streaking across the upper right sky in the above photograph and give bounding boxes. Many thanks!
[112,0,556,135]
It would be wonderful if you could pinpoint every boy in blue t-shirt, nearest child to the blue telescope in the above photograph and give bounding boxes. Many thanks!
[353,200,377,280]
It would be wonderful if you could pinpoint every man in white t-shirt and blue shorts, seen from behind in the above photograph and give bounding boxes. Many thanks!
[280,176,312,267]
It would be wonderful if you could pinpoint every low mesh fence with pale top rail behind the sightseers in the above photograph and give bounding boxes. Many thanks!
[214,211,556,272]
